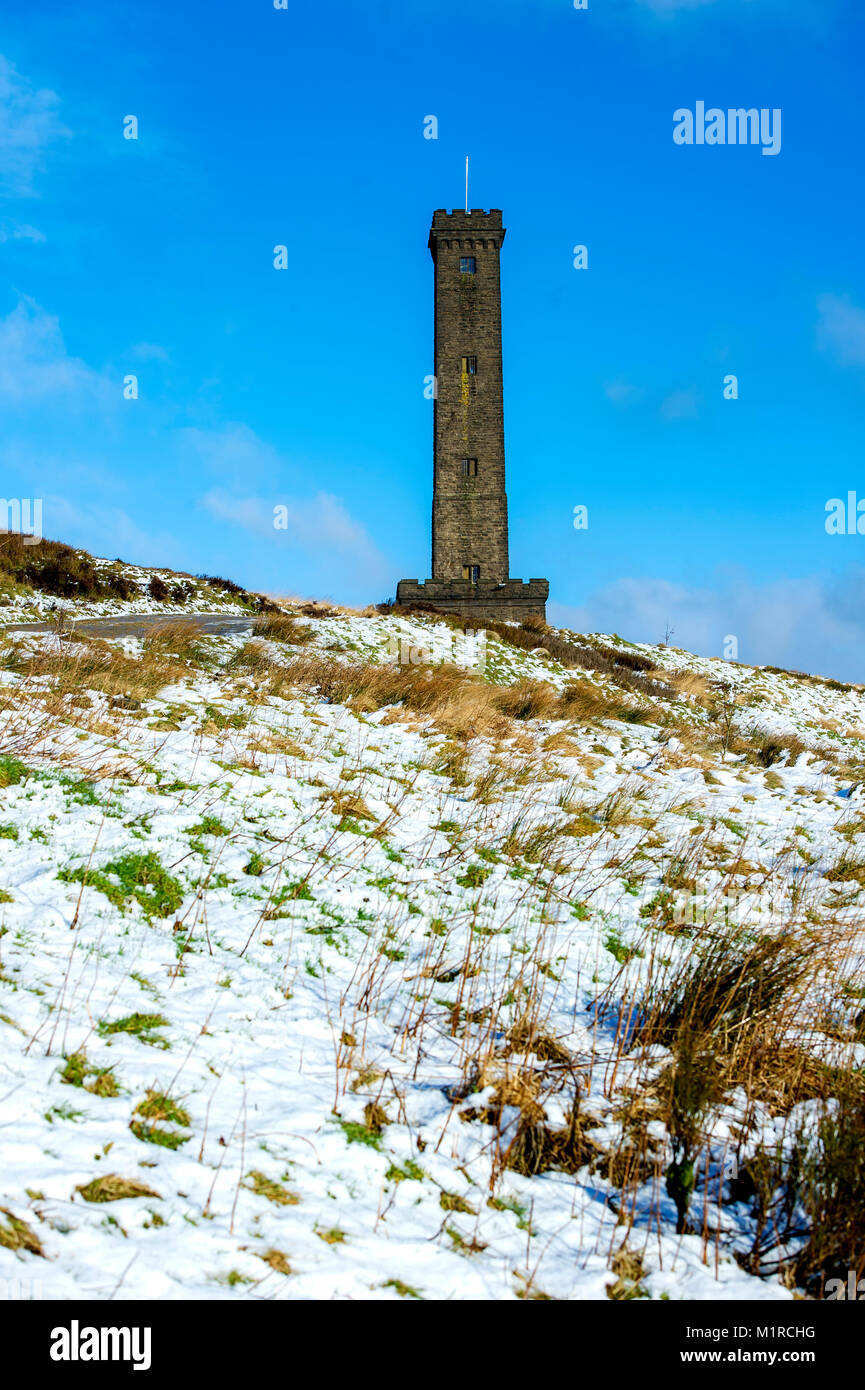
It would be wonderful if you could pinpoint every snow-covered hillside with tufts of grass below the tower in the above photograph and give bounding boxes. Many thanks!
[0,609,865,1300]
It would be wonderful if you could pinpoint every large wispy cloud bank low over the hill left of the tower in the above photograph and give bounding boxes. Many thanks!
[0,297,392,596]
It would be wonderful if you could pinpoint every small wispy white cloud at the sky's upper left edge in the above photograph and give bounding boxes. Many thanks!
[0,54,70,197]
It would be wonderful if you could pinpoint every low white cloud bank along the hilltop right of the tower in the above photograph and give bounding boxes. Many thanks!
[549,566,865,680]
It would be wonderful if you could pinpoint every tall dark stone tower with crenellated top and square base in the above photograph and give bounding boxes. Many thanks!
[396,209,549,620]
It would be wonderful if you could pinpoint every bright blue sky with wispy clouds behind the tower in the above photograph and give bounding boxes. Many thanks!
[0,0,865,678]
